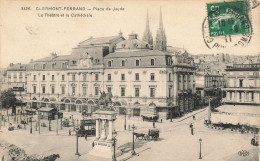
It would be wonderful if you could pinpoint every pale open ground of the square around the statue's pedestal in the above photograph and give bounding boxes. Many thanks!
[0,108,258,161]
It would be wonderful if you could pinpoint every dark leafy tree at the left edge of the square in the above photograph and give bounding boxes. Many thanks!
[0,89,16,115]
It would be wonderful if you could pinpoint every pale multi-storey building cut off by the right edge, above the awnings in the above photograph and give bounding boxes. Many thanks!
[223,63,260,105]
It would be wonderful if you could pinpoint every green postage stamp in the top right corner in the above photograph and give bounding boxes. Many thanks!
[207,0,251,37]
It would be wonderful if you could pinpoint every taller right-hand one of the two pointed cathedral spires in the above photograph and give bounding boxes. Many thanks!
[154,8,167,51]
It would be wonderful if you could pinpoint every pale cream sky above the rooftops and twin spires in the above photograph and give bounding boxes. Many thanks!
[0,0,260,67]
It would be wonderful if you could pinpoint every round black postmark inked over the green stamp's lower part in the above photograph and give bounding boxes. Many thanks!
[202,2,252,49]
